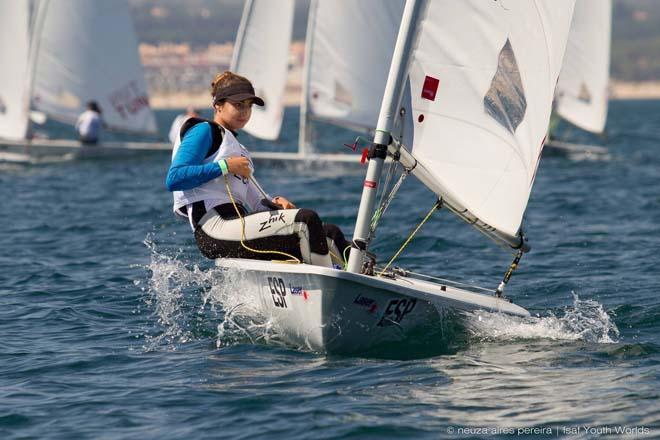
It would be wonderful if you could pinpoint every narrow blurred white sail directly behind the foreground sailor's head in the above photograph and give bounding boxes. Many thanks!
[230,0,294,140]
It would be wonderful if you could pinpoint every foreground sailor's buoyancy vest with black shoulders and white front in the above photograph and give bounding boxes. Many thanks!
[172,118,260,214]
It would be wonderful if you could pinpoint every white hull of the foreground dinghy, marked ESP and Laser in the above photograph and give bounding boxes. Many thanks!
[216,259,529,353]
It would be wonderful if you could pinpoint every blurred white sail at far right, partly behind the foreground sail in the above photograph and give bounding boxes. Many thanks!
[556,0,612,133]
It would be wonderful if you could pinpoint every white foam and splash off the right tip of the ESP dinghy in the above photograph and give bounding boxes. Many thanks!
[467,293,619,344]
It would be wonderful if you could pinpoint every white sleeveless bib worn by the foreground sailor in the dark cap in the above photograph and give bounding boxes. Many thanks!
[172,122,270,215]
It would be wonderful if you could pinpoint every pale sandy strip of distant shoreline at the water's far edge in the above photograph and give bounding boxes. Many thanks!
[150,80,660,109]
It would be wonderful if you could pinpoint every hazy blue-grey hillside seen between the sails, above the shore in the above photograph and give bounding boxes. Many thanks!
[130,0,660,81]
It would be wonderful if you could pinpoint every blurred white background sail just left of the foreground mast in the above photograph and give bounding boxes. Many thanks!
[303,0,405,129]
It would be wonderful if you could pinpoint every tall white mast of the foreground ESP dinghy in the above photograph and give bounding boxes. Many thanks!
[347,0,427,273]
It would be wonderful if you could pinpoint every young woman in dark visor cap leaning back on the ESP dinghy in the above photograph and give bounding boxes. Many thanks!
[166,72,350,267]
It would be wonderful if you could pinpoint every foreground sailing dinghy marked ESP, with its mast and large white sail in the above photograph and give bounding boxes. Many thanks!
[216,0,574,352]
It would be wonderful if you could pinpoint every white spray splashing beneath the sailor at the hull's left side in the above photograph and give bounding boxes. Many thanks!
[138,235,280,350]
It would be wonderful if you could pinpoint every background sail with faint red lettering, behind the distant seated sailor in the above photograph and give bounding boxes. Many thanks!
[32,0,156,133]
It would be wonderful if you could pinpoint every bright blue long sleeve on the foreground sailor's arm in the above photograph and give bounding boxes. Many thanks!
[165,122,222,191]
